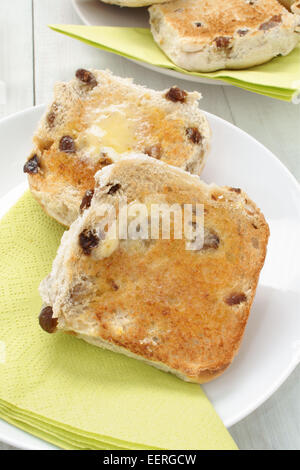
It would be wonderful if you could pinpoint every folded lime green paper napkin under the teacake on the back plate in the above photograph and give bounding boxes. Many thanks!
[50,25,300,103]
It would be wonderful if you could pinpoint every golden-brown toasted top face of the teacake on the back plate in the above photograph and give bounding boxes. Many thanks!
[157,0,287,43]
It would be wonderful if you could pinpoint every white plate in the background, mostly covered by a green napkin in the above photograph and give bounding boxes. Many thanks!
[72,0,231,86]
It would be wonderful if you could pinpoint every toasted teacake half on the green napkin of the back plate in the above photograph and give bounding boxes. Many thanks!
[149,0,300,72]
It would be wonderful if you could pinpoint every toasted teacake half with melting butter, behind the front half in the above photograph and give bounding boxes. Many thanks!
[28,70,210,226]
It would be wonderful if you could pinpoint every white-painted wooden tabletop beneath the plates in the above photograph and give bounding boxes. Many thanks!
[0,0,300,450]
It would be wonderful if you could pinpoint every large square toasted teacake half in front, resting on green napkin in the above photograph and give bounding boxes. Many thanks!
[40,155,269,383]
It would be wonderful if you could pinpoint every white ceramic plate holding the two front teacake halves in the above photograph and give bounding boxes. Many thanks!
[0,106,300,449]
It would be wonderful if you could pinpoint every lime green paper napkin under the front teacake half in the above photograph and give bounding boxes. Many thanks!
[0,192,236,450]
